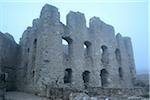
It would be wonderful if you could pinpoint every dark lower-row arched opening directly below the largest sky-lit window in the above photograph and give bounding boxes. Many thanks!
[64,68,72,83]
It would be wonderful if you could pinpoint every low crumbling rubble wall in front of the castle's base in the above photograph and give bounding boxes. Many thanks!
[38,87,144,100]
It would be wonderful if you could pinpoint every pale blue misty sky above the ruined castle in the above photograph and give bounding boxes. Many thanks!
[0,0,148,73]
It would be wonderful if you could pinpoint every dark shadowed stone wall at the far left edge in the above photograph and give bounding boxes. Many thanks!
[0,32,19,90]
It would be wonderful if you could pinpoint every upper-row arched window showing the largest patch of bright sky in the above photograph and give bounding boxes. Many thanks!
[62,37,72,56]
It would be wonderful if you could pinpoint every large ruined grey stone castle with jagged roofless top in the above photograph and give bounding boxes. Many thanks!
[0,4,136,95]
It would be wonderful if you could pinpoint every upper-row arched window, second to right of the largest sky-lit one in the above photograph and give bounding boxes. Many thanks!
[101,45,109,64]
